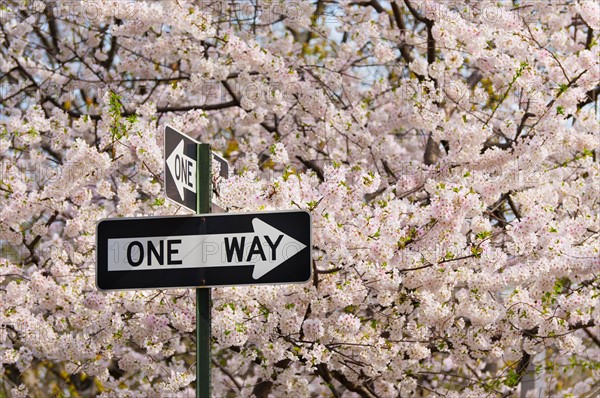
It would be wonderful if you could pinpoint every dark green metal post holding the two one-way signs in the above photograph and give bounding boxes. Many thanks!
[196,144,212,398]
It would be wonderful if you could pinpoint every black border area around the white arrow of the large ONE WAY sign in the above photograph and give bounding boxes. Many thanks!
[96,210,313,291]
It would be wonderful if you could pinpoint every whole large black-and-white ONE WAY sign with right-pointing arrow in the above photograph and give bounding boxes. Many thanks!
[96,211,312,290]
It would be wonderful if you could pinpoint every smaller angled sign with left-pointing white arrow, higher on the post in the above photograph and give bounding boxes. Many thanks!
[165,126,229,211]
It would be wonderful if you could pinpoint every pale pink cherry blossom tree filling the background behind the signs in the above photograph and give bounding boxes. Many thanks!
[0,0,600,397]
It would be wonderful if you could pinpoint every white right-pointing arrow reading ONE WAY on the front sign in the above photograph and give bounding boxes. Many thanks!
[108,218,306,280]
